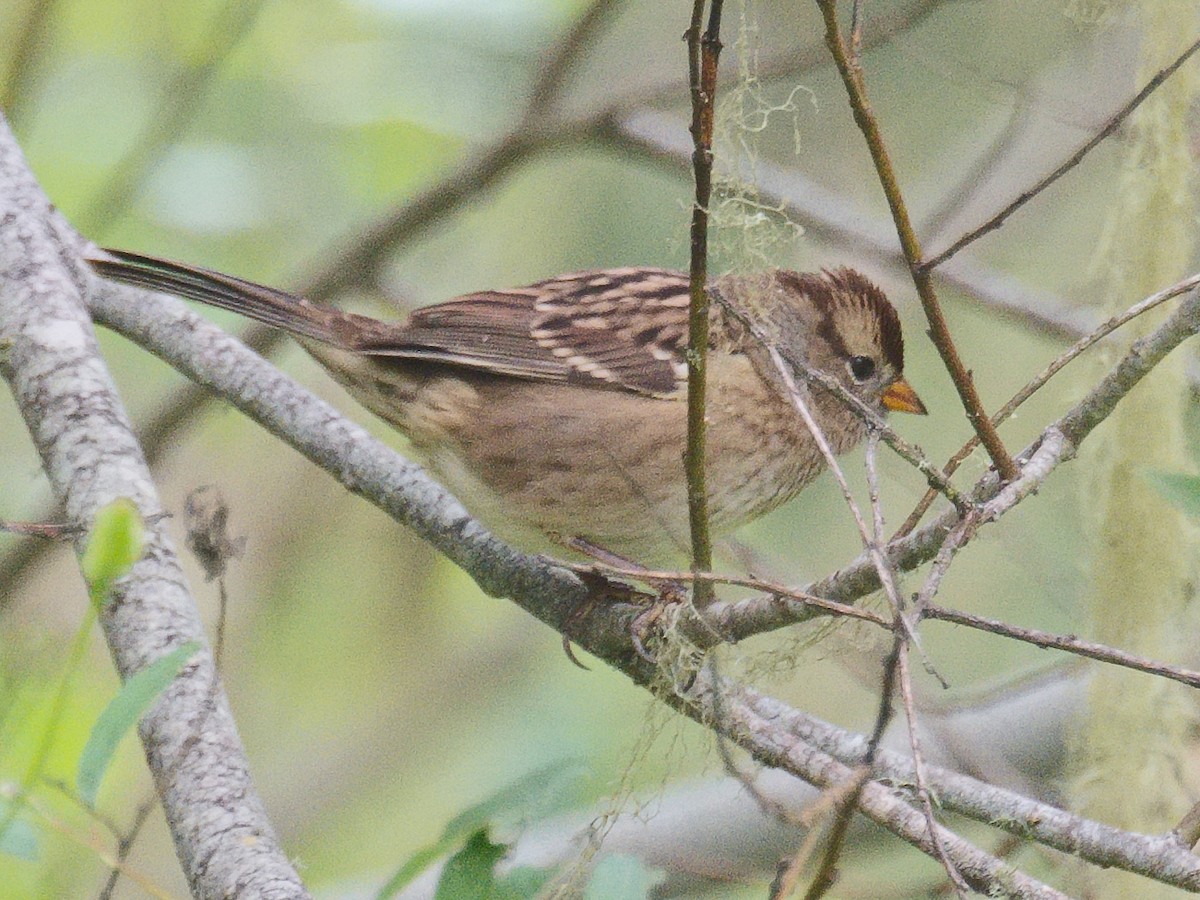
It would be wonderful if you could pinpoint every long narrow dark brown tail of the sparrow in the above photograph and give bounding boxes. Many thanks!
[88,250,347,347]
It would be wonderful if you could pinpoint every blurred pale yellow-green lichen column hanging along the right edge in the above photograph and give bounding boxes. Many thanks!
[1069,0,1200,898]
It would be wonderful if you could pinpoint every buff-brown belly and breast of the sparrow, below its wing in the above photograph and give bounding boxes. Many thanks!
[415,374,820,565]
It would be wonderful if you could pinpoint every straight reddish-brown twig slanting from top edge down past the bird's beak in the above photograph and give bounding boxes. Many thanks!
[817,0,1018,481]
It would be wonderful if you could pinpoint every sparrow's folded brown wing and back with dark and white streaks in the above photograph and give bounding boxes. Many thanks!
[354,268,688,396]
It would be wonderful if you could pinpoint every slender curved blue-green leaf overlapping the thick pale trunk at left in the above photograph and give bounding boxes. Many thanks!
[76,641,200,806]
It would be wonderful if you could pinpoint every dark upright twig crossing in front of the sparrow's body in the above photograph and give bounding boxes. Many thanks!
[684,0,722,610]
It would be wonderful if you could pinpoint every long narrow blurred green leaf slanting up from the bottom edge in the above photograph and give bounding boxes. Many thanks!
[377,761,583,900]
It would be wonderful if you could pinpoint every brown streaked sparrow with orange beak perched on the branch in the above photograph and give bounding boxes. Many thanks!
[89,251,925,564]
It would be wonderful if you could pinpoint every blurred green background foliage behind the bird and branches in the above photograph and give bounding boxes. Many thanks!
[0,0,1180,898]
